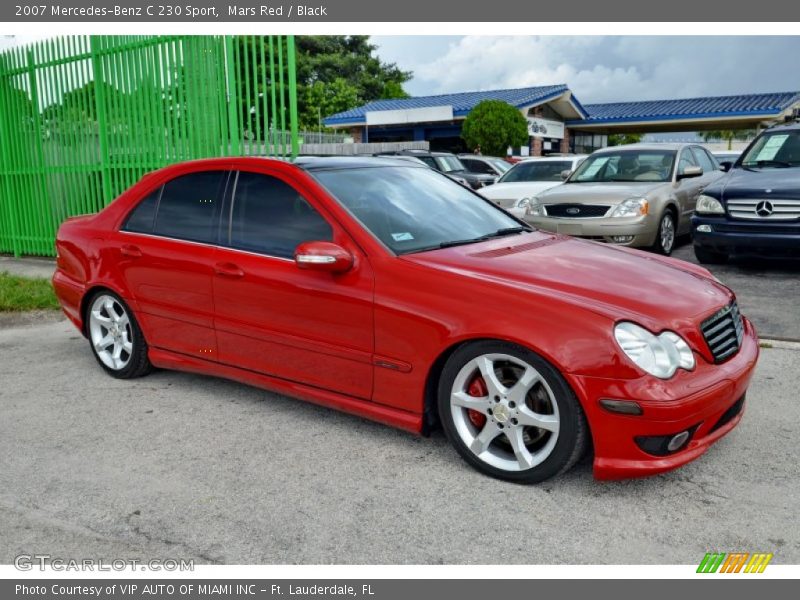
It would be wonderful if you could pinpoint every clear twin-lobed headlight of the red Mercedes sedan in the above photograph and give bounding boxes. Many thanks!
[614,321,694,379]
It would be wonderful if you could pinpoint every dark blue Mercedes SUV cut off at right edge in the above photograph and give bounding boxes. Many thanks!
[692,123,800,263]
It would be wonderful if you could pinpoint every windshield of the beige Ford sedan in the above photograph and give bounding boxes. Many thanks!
[567,150,675,183]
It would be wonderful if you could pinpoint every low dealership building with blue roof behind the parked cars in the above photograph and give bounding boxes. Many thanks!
[323,84,800,156]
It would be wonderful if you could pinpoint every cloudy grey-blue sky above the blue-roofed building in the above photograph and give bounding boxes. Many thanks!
[372,36,800,104]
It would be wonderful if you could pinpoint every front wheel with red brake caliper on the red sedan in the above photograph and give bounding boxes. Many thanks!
[438,340,589,483]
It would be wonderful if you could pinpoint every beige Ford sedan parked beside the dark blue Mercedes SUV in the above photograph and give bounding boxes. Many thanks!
[525,144,723,255]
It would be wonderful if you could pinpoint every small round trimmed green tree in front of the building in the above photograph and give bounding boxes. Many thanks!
[461,100,529,156]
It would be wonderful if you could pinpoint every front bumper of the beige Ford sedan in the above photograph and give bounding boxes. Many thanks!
[523,214,658,248]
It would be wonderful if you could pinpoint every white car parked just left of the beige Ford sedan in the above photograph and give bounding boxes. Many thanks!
[480,155,586,218]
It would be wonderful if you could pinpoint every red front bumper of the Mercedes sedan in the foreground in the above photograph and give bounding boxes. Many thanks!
[569,319,759,479]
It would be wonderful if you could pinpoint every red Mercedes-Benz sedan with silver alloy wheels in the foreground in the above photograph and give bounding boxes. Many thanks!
[53,158,759,482]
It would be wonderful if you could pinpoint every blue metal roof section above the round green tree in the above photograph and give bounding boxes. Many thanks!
[323,84,587,126]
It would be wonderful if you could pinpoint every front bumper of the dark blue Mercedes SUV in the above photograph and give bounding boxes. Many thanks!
[692,215,800,257]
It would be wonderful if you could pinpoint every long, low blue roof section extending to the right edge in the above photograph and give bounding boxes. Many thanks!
[567,92,800,125]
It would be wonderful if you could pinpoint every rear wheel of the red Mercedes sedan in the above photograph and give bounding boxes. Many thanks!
[84,290,153,379]
